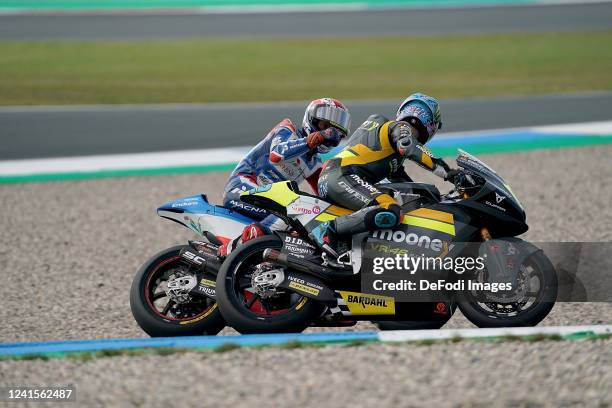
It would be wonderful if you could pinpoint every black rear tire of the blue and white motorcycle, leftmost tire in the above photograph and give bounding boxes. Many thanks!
[130,245,225,337]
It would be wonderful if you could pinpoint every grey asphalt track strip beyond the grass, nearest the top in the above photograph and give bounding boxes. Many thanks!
[0,3,612,41]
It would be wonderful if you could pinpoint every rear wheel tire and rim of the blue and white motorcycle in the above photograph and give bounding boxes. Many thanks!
[130,245,225,337]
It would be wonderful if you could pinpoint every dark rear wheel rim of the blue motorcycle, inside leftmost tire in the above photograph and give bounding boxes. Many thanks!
[144,256,216,323]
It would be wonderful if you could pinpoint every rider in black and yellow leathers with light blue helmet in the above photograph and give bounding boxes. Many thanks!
[313,94,455,245]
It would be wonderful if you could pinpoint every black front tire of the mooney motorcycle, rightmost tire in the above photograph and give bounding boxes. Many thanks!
[458,251,558,327]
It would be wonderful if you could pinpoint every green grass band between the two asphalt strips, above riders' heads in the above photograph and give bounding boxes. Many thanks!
[0,31,612,105]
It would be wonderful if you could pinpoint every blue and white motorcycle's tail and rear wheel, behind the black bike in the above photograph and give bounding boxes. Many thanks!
[130,195,253,337]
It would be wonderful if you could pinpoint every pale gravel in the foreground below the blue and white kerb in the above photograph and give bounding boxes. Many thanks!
[0,339,612,408]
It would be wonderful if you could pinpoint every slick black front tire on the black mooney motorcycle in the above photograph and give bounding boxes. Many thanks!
[458,251,558,327]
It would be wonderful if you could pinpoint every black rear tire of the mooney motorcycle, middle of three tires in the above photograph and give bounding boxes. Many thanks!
[216,235,323,334]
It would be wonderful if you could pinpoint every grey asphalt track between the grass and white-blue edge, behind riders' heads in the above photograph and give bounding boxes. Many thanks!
[0,93,612,160]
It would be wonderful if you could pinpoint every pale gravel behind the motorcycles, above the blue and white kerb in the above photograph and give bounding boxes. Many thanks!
[0,146,612,342]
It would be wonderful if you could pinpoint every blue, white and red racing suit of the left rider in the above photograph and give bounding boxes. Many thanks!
[223,119,322,230]
